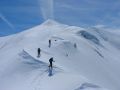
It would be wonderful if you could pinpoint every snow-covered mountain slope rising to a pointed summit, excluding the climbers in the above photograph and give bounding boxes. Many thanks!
[0,20,120,90]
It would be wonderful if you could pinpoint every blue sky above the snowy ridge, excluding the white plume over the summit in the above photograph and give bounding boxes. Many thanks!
[0,0,120,36]
